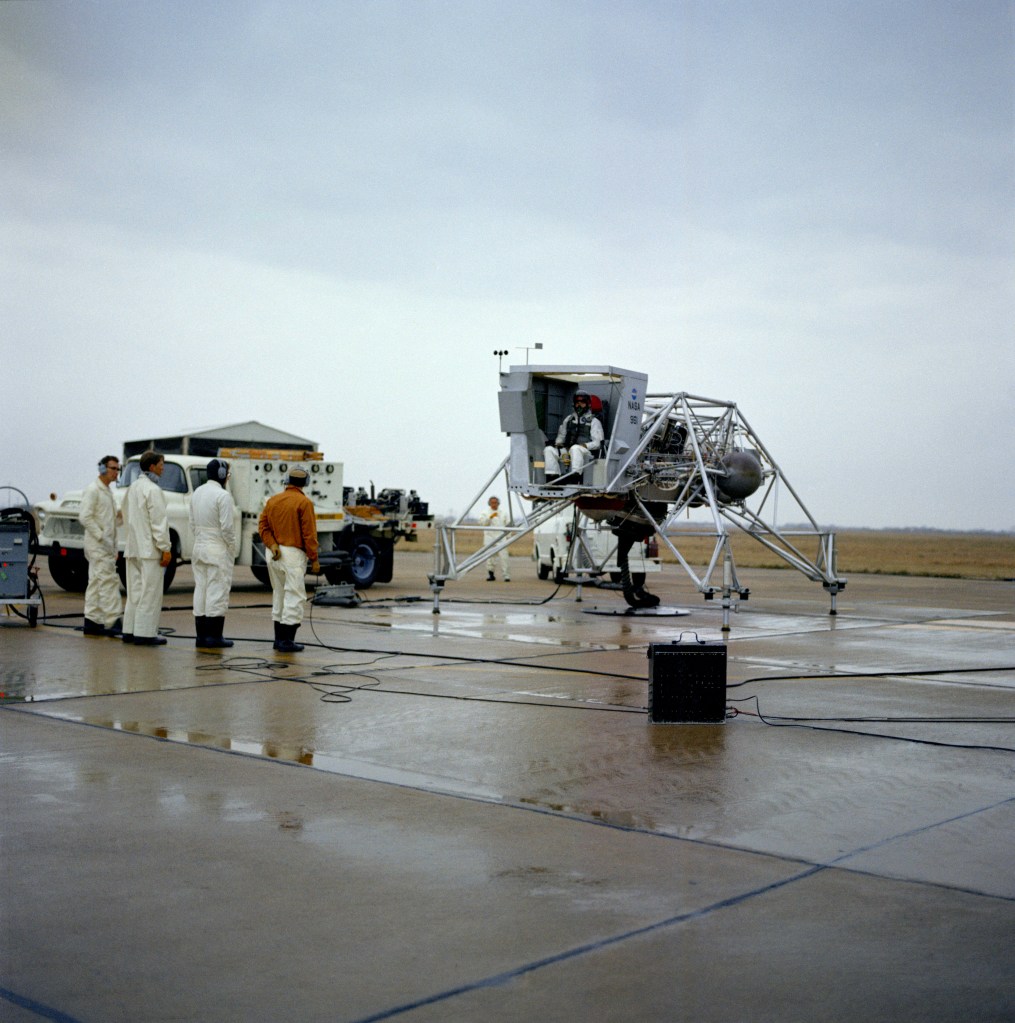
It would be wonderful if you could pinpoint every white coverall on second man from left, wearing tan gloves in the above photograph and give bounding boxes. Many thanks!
[124,473,172,637]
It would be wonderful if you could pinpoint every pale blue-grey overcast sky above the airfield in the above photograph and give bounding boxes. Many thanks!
[0,0,1015,529]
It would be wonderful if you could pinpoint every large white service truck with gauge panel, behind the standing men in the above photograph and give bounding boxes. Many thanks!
[34,448,433,591]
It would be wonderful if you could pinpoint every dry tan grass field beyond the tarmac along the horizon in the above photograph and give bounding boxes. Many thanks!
[435,530,1015,579]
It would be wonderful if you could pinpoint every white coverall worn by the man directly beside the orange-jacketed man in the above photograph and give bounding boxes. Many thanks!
[190,480,236,618]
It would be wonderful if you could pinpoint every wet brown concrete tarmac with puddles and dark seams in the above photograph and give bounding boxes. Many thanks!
[0,551,1015,1023]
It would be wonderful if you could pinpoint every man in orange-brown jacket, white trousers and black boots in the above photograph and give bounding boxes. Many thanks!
[258,469,320,654]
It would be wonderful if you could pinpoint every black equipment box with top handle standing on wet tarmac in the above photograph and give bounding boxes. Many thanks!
[649,641,726,724]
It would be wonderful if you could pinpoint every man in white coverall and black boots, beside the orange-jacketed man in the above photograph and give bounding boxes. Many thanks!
[190,458,238,647]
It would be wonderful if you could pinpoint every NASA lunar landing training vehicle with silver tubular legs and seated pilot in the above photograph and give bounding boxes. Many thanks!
[430,365,846,631]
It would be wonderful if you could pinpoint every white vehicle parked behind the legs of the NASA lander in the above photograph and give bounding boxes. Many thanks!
[532,507,662,586]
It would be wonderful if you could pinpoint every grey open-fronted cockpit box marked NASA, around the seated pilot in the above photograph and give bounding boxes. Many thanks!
[499,366,649,497]
